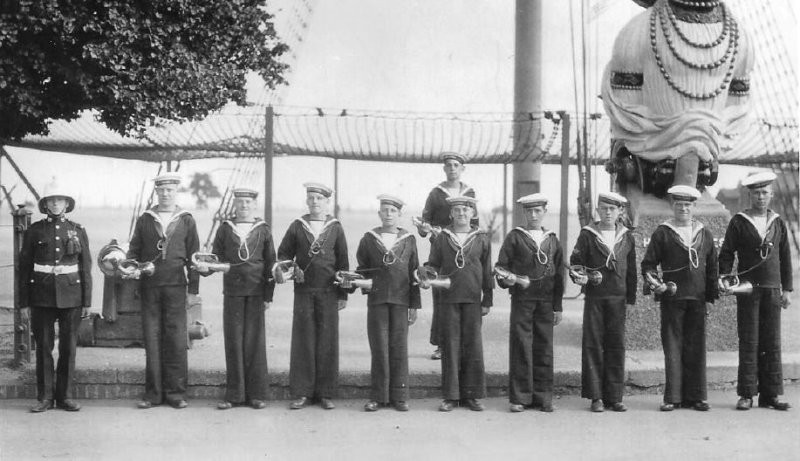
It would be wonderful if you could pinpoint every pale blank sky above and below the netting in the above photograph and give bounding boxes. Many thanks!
[0,0,797,215]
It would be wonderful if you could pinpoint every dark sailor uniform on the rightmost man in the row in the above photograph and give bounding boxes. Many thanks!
[719,210,793,398]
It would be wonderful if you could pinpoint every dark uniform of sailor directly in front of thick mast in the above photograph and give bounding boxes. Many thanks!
[497,227,564,406]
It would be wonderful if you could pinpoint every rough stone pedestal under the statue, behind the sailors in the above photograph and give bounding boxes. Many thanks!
[625,192,738,351]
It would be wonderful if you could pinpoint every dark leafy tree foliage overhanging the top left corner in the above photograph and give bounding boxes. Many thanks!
[0,0,287,140]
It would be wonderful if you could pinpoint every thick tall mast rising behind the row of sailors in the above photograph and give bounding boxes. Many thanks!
[512,0,543,226]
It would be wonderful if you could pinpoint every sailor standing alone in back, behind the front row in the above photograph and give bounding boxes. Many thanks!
[415,156,478,360]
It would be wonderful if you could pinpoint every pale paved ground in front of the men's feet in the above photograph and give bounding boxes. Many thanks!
[0,386,800,461]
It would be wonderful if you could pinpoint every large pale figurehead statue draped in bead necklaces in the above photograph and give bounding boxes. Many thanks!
[602,0,754,221]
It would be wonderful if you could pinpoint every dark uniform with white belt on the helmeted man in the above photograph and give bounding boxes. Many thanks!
[19,216,92,401]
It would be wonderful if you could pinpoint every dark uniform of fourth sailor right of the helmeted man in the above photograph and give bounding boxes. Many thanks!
[356,228,420,403]
